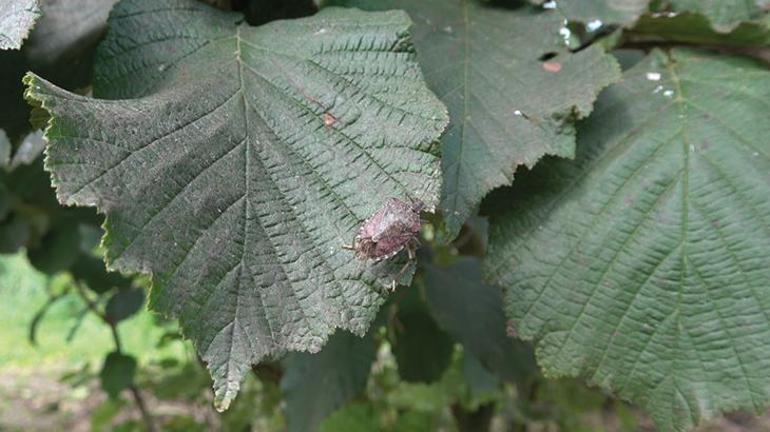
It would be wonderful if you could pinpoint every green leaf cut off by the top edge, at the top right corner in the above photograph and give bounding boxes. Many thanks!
[665,0,766,33]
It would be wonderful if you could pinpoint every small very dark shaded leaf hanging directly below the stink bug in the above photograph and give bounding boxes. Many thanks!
[392,287,454,383]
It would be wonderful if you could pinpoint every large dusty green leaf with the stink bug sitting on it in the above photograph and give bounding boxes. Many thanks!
[26,0,447,409]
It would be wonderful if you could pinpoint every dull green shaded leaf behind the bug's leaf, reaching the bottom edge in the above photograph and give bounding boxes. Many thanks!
[281,331,377,432]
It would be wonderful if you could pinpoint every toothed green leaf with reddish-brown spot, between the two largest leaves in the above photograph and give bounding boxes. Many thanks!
[332,0,619,238]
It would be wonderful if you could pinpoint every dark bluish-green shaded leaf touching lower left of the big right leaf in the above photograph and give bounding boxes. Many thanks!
[425,257,535,381]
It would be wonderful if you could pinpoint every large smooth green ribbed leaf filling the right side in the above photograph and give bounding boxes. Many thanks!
[486,50,770,430]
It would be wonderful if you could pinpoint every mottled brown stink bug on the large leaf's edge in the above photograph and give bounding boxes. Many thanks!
[342,198,425,289]
